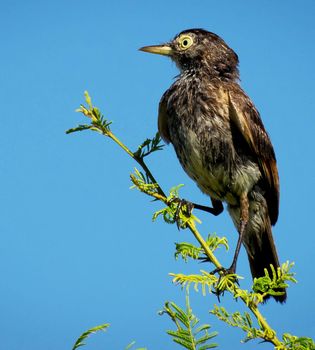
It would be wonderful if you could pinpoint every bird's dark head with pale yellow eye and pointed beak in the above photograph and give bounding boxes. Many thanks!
[140,29,238,79]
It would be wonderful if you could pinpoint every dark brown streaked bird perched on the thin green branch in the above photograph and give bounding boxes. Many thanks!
[139,28,287,303]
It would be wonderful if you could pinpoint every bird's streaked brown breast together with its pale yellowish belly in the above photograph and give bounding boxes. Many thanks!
[167,78,261,205]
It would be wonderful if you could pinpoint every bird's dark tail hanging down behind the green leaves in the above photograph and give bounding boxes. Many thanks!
[229,198,287,303]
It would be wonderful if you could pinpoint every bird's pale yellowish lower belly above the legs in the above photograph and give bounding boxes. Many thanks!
[173,130,261,205]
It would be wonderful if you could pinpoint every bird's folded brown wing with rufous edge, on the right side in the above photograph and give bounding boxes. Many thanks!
[228,89,279,225]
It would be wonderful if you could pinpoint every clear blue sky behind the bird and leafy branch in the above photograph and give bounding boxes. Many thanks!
[0,0,315,350]
